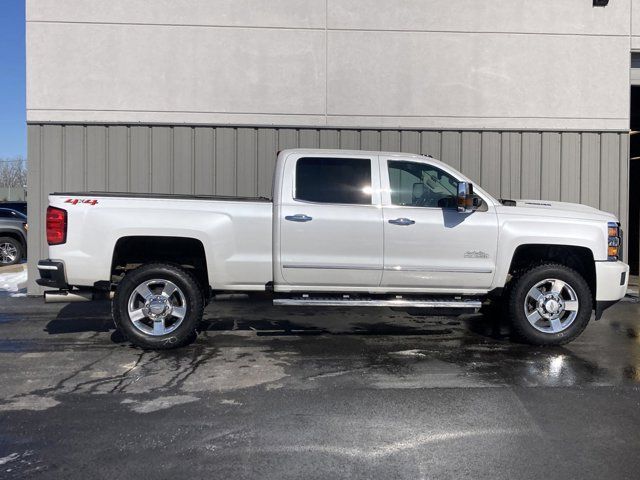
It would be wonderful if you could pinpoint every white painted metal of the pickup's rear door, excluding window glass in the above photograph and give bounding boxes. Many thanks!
[274,152,383,291]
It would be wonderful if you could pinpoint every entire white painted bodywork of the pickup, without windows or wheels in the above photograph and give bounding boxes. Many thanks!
[43,149,628,301]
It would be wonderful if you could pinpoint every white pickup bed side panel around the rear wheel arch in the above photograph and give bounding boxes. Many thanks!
[49,193,272,290]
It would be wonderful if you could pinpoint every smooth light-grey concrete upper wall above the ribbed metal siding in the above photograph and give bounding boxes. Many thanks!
[27,0,631,130]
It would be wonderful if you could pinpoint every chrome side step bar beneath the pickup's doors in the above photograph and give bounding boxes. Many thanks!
[273,297,482,310]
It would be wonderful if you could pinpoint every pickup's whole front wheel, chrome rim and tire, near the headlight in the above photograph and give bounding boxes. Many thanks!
[507,264,593,345]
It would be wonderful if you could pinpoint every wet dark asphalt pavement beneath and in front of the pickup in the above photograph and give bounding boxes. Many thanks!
[0,297,640,480]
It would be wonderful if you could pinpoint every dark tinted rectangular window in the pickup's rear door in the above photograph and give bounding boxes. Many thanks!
[295,157,371,205]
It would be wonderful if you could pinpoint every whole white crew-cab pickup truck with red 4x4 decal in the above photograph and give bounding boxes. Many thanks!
[38,149,629,349]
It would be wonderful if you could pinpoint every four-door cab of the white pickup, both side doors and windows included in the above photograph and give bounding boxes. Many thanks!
[273,151,498,295]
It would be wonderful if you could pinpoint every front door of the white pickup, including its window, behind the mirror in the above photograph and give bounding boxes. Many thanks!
[381,158,498,291]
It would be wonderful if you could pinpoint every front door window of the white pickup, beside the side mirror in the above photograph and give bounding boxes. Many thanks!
[387,160,458,208]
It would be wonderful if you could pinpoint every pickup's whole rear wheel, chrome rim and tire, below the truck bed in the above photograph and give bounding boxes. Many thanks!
[112,263,204,350]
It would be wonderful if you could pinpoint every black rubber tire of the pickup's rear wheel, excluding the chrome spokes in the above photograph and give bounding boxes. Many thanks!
[111,263,204,350]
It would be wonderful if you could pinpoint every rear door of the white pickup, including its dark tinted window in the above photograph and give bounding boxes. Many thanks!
[275,154,383,290]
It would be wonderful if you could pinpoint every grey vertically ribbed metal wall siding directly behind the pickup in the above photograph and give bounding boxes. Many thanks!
[28,124,629,293]
